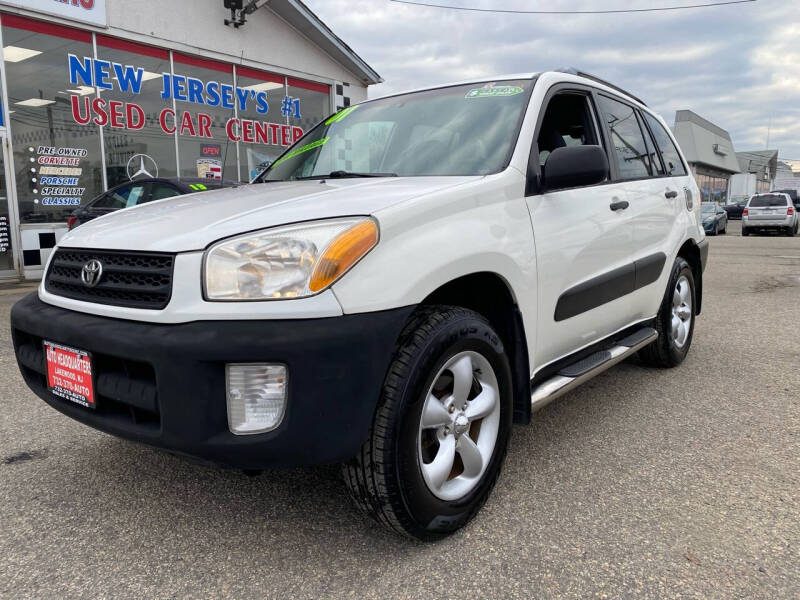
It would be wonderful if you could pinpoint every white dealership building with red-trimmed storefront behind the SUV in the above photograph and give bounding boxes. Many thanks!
[0,0,381,278]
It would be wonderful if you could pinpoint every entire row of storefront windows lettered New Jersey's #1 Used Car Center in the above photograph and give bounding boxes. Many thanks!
[0,13,334,234]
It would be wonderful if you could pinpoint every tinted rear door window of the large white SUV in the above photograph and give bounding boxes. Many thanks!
[598,96,651,179]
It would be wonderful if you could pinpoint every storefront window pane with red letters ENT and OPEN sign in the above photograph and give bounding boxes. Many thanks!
[236,67,286,181]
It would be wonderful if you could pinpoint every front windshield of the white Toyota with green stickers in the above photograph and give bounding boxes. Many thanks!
[254,79,534,183]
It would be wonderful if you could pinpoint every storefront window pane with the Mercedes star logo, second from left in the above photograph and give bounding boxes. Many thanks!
[97,35,177,187]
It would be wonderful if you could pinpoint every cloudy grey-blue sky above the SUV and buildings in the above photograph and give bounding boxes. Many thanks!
[305,0,800,159]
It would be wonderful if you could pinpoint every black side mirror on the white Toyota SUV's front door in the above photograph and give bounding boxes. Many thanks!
[542,146,608,192]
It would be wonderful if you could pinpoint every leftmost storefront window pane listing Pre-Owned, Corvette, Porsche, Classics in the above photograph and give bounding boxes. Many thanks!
[2,14,103,223]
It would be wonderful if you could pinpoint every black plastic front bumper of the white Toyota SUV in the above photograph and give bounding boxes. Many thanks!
[11,294,413,469]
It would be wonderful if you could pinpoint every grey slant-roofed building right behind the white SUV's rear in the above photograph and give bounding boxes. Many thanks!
[673,110,739,204]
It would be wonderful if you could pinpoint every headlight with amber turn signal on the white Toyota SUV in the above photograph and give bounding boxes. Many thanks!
[205,217,378,300]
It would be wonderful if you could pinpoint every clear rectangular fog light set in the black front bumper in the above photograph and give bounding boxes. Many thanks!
[225,363,288,435]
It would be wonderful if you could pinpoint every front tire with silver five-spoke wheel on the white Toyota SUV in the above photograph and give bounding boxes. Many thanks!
[342,306,513,541]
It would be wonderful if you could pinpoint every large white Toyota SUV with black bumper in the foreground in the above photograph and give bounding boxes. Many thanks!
[11,72,707,539]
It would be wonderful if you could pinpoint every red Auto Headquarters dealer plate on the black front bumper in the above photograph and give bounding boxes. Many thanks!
[44,342,97,409]
